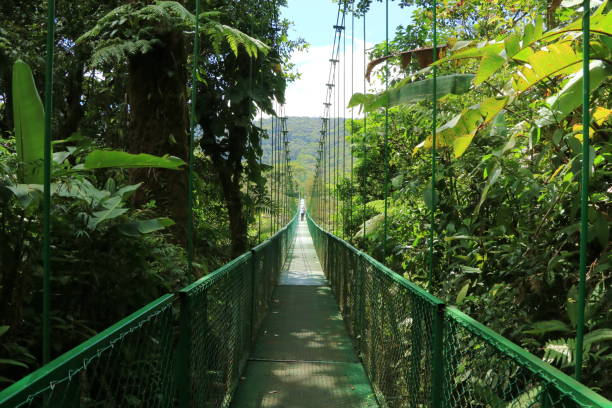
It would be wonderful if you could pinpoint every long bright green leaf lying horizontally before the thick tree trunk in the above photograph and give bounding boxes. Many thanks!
[75,150,185,170]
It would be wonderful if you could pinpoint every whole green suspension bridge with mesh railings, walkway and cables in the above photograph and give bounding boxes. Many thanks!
[0,0,612,408]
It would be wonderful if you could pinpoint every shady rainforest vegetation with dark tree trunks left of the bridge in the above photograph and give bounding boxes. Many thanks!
[0,0,304,387]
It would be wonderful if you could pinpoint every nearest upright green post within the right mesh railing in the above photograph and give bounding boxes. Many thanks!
[430,303,448,408]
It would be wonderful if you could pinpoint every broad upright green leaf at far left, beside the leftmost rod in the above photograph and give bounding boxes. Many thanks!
[12,60,45,184]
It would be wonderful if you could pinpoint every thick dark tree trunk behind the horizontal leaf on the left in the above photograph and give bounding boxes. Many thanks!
[127,32,188,242]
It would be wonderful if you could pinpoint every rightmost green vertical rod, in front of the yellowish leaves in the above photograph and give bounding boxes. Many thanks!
[574,0,591,381]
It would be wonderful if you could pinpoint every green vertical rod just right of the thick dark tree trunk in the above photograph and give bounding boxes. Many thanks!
[187,0,200,276]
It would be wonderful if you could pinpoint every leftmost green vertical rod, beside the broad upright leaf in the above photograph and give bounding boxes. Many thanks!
[42,0,55,364]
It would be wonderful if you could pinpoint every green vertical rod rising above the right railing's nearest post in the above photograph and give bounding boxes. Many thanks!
[428,0,438,290]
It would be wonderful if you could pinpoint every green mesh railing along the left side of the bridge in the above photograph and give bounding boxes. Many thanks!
[0,217,297,408]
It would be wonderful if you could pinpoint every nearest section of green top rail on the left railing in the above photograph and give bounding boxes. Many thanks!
[0,294,176,408]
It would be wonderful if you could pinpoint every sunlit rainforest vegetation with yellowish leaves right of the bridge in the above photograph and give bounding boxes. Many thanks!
[318,0,612,398]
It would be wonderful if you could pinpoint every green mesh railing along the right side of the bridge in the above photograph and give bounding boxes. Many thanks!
[308,217,612,408]
